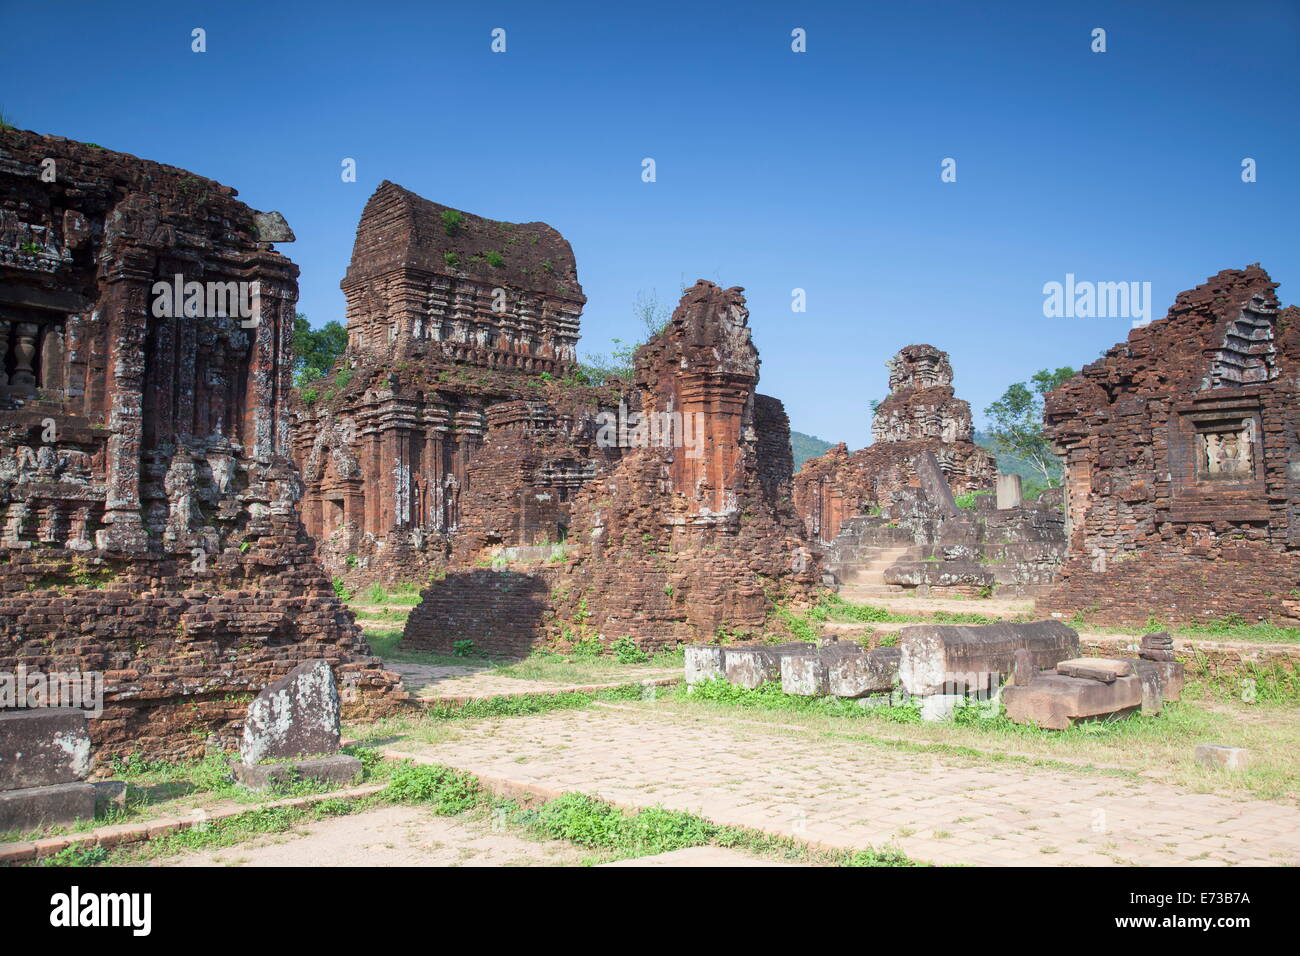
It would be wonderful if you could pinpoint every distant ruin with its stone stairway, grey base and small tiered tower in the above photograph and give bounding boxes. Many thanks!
[794,345,1065,597]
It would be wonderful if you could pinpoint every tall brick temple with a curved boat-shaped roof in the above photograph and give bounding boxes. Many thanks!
[294,182,599,584]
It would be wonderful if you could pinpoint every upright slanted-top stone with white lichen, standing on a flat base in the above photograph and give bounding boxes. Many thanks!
[239,661,339,765]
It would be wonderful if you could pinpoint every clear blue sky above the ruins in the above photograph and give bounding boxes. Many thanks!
[0,0,1300,447]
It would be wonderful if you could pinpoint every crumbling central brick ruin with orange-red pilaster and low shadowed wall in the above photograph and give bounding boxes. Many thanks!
[403,281,818,653]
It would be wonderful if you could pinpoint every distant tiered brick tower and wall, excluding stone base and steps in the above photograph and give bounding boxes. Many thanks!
[794,345,997,545]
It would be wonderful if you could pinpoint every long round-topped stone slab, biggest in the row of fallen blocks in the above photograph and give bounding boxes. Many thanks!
[898,620,1080,696]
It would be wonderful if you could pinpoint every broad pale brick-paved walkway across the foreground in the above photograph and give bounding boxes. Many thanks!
[385,708,1300,866]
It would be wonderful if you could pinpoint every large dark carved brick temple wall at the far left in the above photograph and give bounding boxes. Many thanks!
[0,130,397,757]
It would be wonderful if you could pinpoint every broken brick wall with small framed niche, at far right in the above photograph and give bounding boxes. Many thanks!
[1040,264,1300,626]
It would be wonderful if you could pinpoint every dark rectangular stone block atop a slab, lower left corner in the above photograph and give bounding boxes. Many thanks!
[0,708,91,791]
